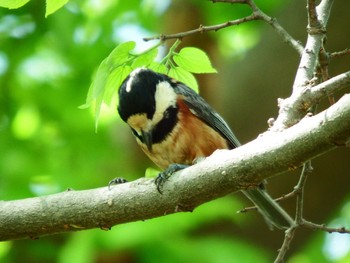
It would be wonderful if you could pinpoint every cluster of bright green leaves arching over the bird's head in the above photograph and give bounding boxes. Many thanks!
[81,40,217,130]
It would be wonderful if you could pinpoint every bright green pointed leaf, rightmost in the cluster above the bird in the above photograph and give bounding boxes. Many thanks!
[173,47,217,73]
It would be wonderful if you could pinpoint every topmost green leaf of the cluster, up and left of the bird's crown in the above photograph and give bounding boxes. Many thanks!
[107,41,136,67]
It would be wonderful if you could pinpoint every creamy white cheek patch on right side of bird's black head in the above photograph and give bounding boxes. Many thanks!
[152,81,176,125]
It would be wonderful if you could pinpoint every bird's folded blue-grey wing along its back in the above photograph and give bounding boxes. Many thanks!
[174,82,241,148]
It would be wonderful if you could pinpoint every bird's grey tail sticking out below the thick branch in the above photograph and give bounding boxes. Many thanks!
[242,188,294,229]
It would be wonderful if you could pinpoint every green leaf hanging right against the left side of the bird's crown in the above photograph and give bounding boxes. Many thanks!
[103,66,132,105]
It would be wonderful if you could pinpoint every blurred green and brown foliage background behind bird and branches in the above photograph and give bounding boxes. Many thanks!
[0,0,350,263]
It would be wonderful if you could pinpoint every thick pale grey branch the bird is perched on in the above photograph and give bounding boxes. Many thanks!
[0,94,350,241]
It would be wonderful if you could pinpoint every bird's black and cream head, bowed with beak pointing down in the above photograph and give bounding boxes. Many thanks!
[118,68,177,151]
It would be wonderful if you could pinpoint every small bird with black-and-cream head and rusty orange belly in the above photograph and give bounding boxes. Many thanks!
[115,68,293,229]
